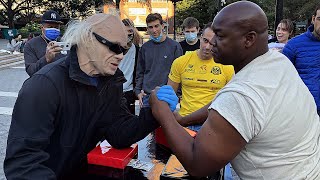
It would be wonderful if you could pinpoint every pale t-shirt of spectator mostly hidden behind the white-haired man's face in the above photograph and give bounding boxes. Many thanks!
[119,45,136,92]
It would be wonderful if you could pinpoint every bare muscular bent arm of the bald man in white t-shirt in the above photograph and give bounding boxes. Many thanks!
[151,94,246,177]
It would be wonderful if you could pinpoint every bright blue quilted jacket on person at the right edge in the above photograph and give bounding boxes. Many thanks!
[283,25,320,111]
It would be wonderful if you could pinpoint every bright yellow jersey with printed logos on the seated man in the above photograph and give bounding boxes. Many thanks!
[169,50,234,116]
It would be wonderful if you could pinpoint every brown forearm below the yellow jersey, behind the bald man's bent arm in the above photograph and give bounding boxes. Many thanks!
[179,102,211,127]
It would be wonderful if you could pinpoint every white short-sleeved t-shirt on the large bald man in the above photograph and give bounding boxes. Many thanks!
[209,51,320,180]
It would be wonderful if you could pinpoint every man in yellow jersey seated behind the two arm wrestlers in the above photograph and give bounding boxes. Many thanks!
[168,23,234,131]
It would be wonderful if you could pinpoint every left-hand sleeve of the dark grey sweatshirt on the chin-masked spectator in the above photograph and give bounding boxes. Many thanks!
[134,47,145,96]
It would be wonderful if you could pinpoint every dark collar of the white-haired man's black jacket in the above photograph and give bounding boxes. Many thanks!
[66,45,125,87]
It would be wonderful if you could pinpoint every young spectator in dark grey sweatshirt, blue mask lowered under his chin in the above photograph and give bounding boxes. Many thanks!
[134,13,182,107]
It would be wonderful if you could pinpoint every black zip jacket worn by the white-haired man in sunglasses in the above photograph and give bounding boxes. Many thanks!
[4,47,158,180]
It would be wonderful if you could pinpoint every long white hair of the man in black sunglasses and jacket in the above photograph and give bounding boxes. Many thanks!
[61,14,114,46]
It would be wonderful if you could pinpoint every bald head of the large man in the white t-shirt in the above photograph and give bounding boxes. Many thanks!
[211,1,268,72]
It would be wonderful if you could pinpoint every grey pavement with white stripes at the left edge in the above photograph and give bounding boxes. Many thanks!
[0,39,29,180]
